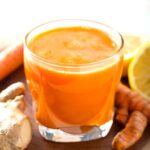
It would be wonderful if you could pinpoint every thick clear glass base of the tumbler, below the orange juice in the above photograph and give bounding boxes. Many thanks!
[39,120,113,142]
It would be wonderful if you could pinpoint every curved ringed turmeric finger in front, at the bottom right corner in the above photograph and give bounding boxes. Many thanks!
[112,111,147,150]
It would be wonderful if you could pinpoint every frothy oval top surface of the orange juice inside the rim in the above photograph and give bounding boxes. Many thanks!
[29,27,117,65]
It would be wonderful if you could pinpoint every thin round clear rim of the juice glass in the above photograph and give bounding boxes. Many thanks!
[24,19,124,69]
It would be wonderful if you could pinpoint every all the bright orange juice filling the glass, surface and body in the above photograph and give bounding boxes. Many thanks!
[25,27,122,128]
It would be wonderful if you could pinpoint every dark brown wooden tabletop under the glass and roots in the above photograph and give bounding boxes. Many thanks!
[0,67,150,150]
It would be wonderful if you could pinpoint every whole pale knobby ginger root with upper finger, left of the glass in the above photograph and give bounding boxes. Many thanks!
[0,82,32,150]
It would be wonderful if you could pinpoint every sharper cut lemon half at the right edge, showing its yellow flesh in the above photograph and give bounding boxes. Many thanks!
[128,42,150,99]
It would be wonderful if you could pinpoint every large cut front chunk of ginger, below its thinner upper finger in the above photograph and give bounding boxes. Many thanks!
[0,101,32,150]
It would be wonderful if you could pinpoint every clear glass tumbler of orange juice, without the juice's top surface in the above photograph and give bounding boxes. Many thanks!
[24,20,123,142]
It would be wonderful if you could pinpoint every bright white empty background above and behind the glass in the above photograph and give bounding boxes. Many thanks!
[0,0,150,38]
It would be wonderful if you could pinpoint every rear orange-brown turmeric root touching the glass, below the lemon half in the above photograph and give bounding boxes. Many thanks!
[115,83,150,124]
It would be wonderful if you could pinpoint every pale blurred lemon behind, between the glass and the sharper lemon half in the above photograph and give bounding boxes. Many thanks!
[122,34,144,77]
